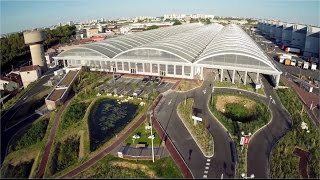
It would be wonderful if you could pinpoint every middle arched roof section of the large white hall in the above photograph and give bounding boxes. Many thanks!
[114,24,223,63]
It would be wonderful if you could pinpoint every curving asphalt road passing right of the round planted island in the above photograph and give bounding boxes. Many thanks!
[247,75,292,178]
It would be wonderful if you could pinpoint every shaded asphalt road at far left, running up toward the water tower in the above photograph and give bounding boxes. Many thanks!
[1,73,53,166]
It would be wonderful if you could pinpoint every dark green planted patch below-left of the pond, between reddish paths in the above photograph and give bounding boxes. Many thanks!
[51,137,80,174]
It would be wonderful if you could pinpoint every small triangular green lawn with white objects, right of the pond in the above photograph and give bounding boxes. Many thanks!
[125,121,161,147]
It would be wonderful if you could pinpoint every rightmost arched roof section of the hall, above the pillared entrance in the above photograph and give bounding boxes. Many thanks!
[195,24,279,72]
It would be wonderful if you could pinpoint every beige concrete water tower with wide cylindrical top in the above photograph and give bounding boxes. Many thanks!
[23,31,47,71]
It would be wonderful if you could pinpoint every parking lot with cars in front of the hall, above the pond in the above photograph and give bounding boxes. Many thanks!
[96,75,174,98]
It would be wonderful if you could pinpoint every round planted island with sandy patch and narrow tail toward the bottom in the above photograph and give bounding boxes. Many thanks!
[209,93,271,178]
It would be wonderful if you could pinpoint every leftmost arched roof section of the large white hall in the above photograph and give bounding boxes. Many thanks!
[57,23,200,58]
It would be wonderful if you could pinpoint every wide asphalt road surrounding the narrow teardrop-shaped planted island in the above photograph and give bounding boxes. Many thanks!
[156,73,236,178]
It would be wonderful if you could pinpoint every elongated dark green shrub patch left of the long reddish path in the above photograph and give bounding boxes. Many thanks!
[9,118,49,152]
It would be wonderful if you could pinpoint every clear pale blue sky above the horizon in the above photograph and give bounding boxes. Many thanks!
[0,0,320,34]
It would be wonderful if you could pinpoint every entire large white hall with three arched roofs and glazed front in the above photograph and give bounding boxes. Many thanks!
[54,23,282,86]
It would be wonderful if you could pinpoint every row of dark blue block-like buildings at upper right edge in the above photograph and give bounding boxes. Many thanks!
[257,20,320,58]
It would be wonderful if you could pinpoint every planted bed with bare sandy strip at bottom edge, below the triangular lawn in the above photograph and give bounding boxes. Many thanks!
[76,155,183,179]
